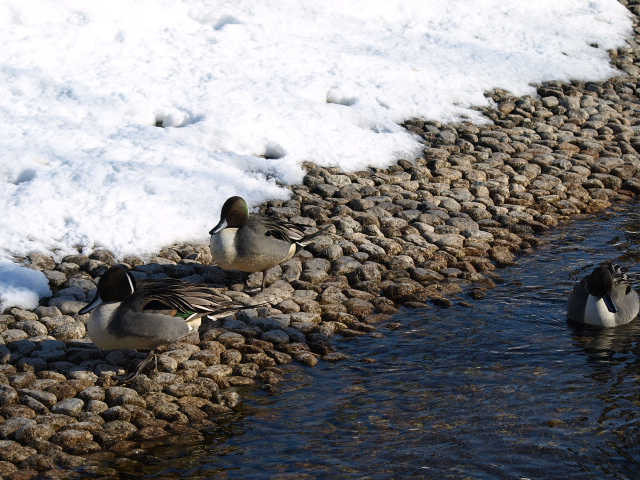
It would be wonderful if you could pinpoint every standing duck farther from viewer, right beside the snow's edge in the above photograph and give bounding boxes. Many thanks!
[209,196,329,291]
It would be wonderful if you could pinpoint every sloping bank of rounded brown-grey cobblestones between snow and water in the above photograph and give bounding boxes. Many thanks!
[0,4,640,478]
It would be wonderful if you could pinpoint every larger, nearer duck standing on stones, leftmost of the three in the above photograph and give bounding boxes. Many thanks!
[78,265,243,383]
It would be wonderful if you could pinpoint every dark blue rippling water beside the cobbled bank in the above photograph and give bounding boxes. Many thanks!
[102,205,640,479]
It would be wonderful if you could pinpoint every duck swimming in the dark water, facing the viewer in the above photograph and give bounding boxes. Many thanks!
[567,263,640,327]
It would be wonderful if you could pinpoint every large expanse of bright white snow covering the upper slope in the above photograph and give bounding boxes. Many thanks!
[0,0,632,308]
